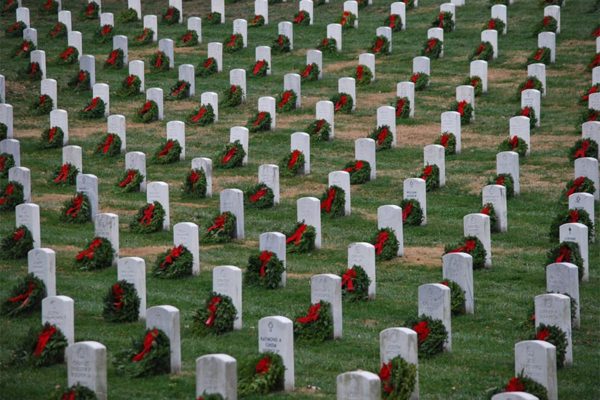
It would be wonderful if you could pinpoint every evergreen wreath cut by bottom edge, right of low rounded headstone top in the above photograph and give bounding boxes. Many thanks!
[379,356,417,400]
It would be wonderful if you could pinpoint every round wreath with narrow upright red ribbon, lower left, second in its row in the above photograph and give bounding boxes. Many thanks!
[102,280,141,322]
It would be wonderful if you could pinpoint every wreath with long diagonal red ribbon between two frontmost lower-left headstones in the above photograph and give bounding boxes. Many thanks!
[115,328,171,378]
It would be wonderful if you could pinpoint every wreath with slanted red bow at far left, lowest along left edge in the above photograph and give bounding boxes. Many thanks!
[11,322,68,367]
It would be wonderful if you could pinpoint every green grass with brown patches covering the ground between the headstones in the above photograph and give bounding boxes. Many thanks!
[0,0,600,399]
